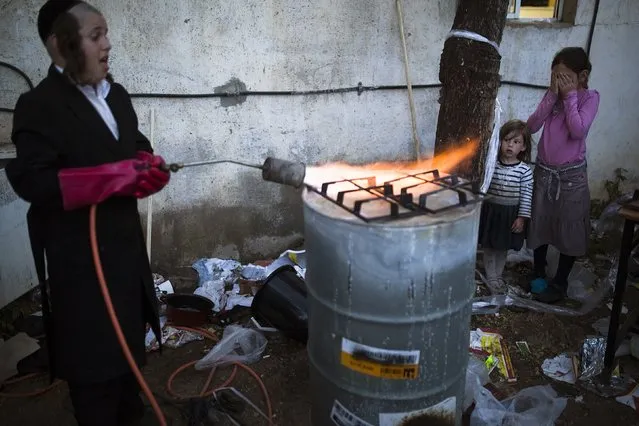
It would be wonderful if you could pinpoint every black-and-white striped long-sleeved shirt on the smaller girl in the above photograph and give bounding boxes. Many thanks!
[488,161,533,218]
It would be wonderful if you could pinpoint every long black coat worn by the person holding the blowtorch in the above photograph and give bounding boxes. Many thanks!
[5,66,160,382]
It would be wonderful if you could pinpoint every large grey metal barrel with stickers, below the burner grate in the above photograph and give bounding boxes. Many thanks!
[303,191,481,426]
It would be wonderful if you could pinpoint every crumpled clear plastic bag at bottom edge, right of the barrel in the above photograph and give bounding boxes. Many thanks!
[470,379,567,426]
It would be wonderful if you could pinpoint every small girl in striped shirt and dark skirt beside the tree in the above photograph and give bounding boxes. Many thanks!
[479,120,533,293]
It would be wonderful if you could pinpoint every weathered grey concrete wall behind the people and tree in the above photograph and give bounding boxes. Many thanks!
[0,0,639,282]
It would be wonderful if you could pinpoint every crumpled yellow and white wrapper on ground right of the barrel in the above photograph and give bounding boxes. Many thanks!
[470,328,517,383]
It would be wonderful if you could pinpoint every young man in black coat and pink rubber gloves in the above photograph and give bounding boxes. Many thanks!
[6,0,169,426]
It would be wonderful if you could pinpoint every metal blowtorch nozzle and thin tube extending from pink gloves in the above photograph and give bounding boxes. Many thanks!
[160,157,306,188]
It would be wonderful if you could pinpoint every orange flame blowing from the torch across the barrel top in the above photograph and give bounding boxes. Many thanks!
[304,140,479,188]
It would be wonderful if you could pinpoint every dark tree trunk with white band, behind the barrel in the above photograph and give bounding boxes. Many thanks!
[435,0,508,183]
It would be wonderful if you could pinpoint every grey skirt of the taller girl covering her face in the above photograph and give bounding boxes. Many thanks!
[527,162,590,256]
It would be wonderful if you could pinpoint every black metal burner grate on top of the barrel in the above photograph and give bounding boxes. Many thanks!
[306,169,485,222]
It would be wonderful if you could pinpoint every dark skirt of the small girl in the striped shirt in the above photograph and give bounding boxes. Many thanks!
[479,201,526,250]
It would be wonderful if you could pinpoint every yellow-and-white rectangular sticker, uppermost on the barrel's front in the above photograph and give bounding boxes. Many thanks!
[340,337,420,380]
